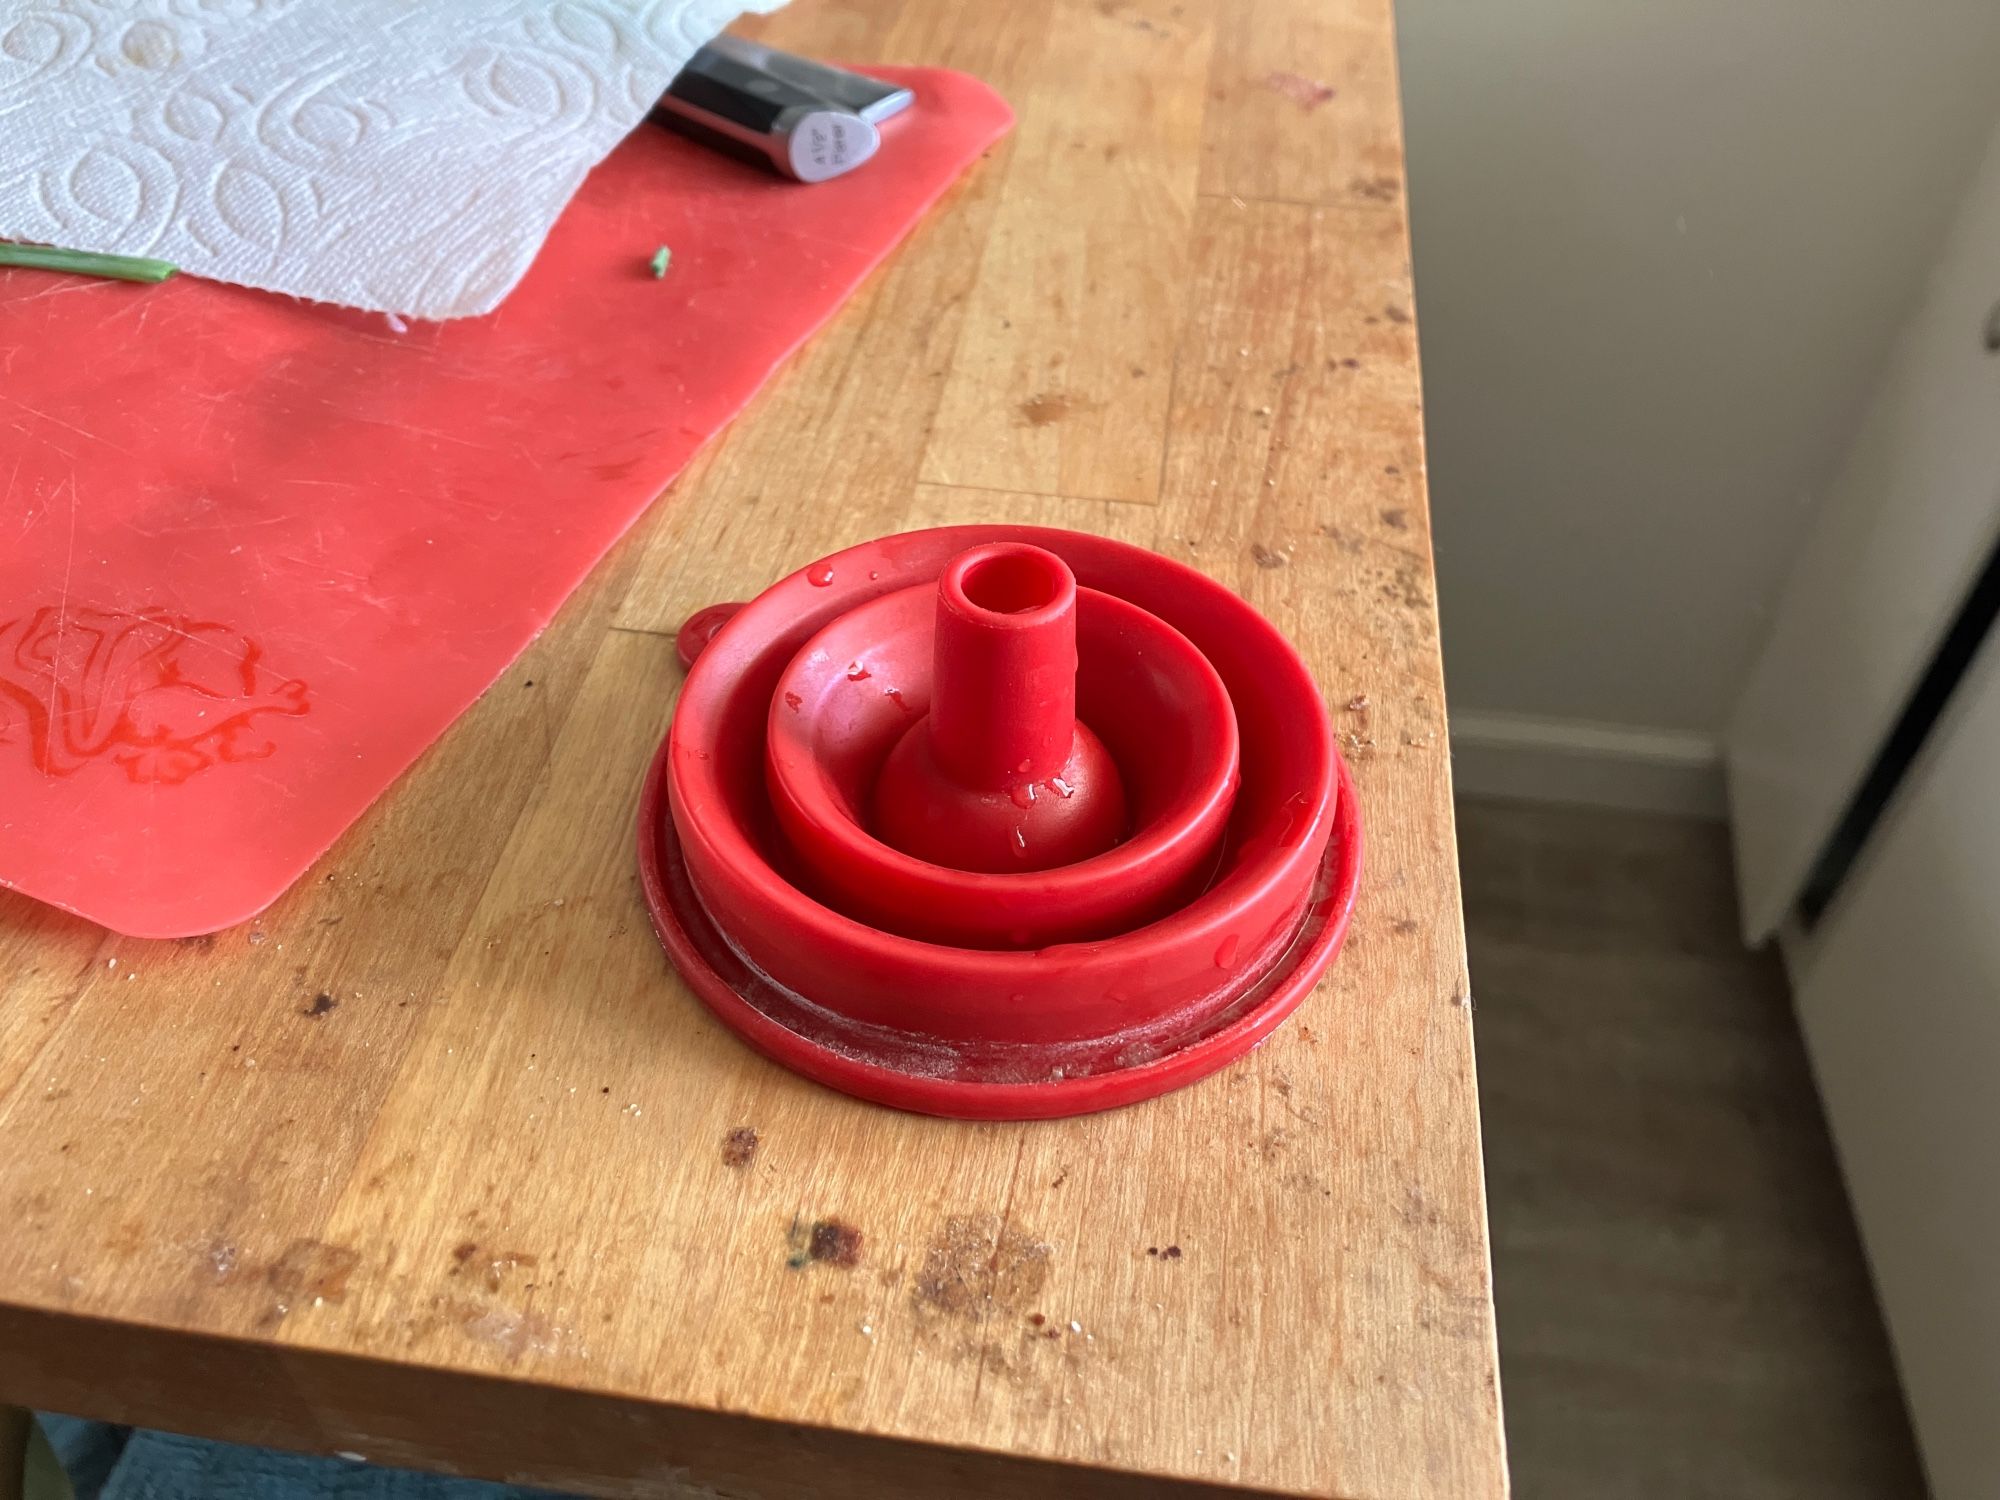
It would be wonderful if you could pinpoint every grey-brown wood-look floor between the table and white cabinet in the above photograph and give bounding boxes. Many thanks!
[1458,798,1924,1500]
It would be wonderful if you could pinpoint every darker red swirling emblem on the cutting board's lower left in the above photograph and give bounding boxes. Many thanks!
[0,604,310,786]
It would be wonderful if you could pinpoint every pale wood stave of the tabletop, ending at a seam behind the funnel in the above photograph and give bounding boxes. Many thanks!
[924,0,1210,500]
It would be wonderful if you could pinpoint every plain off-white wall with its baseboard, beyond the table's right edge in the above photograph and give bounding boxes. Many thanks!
[1396,0,2000,804]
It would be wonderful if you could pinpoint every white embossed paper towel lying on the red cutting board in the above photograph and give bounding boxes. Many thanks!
[0,0,784,318]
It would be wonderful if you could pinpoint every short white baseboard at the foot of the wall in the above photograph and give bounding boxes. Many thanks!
[1450,710,1728,822]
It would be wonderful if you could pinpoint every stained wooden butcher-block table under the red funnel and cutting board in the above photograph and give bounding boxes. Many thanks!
[0,0,1506,1500]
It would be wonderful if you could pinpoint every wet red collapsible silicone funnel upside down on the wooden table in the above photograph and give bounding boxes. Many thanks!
[640,526,1360,1118]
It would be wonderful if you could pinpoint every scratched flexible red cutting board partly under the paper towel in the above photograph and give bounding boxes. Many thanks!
[0,68,1012,936]
